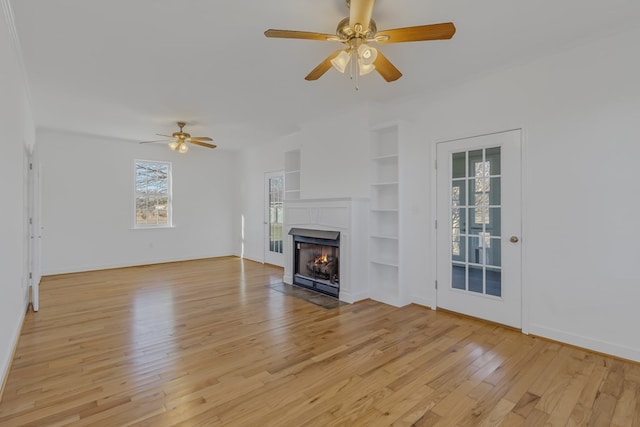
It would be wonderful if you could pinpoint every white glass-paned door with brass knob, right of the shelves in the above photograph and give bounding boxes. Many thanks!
[436,130,522,328]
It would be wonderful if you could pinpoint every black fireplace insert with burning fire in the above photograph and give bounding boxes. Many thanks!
[289,228,340,297]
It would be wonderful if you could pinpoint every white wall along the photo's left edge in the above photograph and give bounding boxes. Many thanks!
[0,4,33,396]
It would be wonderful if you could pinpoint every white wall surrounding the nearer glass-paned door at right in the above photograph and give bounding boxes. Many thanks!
[396,25,640,360]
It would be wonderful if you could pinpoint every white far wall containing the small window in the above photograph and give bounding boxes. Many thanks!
[37,130,236,274]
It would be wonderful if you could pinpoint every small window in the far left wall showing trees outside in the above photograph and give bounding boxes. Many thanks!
[134,160,171,227]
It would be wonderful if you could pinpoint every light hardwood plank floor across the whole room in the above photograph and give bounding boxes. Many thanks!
[0,257,640,426]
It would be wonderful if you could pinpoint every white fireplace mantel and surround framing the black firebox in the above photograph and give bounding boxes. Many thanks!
[283,197,369,303]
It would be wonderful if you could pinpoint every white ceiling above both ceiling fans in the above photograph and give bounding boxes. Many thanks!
[11,0,640,149]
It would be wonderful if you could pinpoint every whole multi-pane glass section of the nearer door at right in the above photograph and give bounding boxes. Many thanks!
[451,147,502,297]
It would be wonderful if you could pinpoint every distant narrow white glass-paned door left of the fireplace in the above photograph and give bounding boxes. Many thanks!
[264,171,284,267]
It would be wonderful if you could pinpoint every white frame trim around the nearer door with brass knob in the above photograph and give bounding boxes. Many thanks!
[431,129,529,333]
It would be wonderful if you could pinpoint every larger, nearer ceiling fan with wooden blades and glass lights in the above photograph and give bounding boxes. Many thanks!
[264,0,456,82]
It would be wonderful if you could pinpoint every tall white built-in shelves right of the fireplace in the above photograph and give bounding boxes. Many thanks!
[369,125,400,305]
